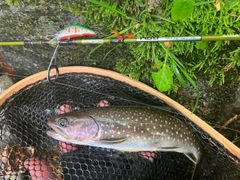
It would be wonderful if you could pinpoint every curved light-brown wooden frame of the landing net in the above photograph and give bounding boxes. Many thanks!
[0,66,240,179]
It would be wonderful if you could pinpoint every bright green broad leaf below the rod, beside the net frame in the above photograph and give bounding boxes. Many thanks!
[152,64,173,92]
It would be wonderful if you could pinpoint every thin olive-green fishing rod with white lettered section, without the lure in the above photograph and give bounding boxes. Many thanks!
[0,34,240,46]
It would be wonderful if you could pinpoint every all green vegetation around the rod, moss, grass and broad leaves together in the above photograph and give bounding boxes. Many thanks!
[4,0,240,111]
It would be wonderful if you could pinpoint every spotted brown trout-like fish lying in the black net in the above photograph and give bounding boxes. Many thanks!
[47,106,202,179]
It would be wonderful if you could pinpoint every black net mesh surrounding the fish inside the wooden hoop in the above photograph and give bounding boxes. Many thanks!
[0,73,240,180]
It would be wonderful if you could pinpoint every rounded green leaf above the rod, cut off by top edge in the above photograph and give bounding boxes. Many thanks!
[171,0,194,21]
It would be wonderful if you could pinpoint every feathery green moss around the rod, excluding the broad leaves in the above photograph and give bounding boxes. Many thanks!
[63,0,240,91]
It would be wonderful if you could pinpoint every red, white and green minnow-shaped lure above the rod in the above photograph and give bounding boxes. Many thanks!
[54,24,96,41]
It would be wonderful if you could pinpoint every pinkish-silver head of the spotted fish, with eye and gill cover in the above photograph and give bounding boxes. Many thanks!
[47,113,99,141]
